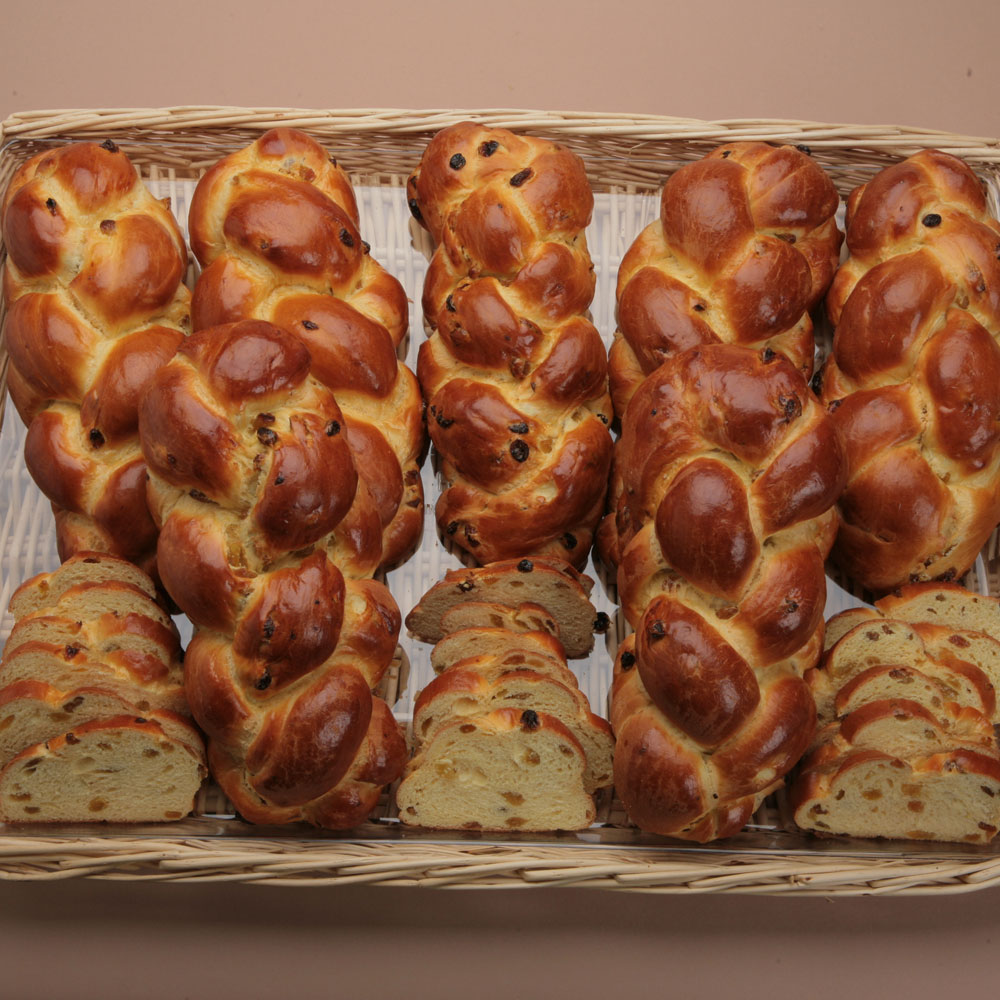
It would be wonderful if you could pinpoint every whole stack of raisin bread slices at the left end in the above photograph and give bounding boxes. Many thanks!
[0,552,206,823]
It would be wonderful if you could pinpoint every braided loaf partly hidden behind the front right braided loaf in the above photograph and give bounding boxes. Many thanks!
[609,142,843,415]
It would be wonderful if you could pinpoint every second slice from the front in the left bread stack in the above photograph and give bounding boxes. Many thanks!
[0,680,201,767]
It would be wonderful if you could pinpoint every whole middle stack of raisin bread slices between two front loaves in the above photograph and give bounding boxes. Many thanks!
[396,559,614,832]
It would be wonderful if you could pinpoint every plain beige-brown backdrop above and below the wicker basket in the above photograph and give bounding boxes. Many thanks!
[0,0,1000,1000]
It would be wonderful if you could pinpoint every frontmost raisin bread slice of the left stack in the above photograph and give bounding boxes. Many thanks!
[0,716,205,823]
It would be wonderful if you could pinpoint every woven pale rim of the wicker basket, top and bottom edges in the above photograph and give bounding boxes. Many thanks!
[0,105,1000,896]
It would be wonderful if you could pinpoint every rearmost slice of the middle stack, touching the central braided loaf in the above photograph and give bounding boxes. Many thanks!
[406,558,598,658]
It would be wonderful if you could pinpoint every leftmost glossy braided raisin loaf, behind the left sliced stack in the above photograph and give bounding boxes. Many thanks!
[3,141,190,569]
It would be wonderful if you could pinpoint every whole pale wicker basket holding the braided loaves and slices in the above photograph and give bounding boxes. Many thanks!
[0,107,1000,896]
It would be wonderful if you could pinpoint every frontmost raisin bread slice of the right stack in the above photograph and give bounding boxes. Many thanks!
[789,743,1000,844]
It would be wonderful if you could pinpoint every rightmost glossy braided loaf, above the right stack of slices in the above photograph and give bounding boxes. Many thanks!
[822,151,1000,592]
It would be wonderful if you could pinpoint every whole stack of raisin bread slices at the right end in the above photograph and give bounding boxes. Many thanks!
[790,584,1000,843]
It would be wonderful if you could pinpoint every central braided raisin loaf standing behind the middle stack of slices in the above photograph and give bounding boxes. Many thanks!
[407,123,611,567]
